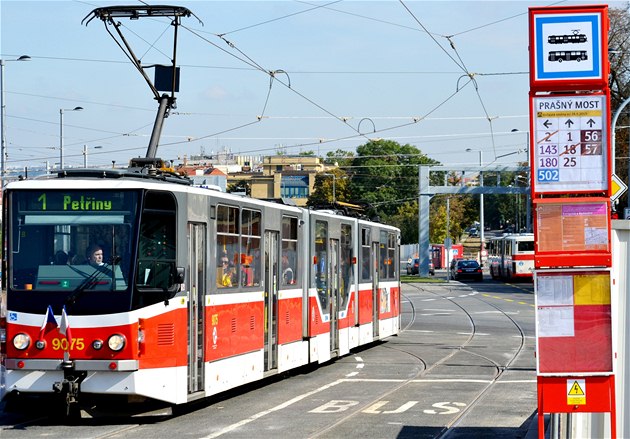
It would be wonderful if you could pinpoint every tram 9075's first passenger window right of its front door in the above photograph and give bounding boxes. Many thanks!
[217,206,239,288]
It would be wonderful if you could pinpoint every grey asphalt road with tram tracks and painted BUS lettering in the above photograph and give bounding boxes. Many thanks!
[0,279,537,439]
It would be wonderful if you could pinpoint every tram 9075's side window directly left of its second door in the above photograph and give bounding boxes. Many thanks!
[242,209,261,287]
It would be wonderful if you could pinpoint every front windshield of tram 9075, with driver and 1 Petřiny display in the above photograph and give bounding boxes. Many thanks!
[7,190,138,312]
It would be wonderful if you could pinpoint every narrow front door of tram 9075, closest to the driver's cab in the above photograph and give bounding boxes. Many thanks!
[187,223,206,393]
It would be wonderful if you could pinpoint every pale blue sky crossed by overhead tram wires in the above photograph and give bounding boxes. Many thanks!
[0,0,627,173]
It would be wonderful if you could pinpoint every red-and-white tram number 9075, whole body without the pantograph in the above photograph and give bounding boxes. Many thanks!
[2,166,401,414]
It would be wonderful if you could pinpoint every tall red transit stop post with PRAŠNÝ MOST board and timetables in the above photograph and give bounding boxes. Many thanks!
[529,5,616,439]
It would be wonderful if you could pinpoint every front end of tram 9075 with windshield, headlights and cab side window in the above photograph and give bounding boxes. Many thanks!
[2,179,185,414]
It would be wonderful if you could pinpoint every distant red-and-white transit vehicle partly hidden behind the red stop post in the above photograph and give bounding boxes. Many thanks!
[486,233,534,281]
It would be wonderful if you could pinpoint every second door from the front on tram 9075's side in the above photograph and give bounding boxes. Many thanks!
[264,231,279,370]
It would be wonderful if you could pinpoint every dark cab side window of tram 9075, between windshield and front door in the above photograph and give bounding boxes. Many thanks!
[134,191,177,306]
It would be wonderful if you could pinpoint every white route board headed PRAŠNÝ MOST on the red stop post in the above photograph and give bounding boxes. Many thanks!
[531,95,610,193]
